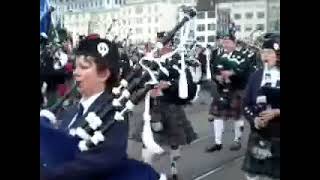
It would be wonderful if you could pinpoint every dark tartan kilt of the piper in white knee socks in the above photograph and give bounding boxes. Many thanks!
[209,90,244,120]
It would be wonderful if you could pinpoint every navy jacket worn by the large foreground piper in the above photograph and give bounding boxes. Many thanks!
[41,92,128,180]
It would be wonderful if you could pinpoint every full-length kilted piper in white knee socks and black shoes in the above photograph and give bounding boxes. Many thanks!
[206,34,254,152]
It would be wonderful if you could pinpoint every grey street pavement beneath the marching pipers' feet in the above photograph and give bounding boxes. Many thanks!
[128,88,249,180]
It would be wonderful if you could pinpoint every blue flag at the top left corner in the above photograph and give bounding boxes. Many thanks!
[40,0,51,35]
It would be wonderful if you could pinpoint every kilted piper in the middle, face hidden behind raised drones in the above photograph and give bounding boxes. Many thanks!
[142,32,197,180]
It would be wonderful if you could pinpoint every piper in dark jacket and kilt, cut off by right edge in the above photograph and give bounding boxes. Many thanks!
[242,34,280,180]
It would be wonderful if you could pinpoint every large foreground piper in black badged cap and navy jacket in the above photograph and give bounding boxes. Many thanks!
[40,36,164,180]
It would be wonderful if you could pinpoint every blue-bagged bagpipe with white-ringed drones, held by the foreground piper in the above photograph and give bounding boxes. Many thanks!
[40,48,170,179]
